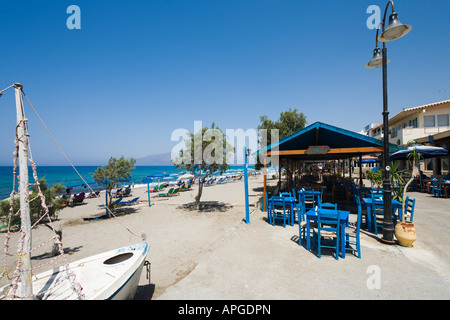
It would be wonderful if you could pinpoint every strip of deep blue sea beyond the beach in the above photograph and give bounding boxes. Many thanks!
[0,166,250,200]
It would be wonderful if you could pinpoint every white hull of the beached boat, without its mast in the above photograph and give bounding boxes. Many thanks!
[0,241,148,300]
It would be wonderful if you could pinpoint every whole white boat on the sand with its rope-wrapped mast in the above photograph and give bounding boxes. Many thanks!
[0,84,149,300]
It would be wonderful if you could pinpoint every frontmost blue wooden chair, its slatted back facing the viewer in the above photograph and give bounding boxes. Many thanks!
[313,205,339,260]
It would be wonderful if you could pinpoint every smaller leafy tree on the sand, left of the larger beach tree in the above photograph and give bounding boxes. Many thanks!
[91,156,136,216]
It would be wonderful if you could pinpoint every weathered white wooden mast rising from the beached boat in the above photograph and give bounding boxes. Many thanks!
[14,83,33,297]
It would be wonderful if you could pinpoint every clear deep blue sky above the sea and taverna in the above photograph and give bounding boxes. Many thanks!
[0,0,450,165]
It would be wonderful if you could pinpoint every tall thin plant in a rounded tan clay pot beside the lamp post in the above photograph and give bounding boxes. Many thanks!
[395,141,421,247]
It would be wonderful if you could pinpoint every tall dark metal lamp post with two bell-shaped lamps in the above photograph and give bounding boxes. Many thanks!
[366,1,412,244]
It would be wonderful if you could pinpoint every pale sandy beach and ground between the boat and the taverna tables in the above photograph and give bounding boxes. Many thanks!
[0,176,450,300]
